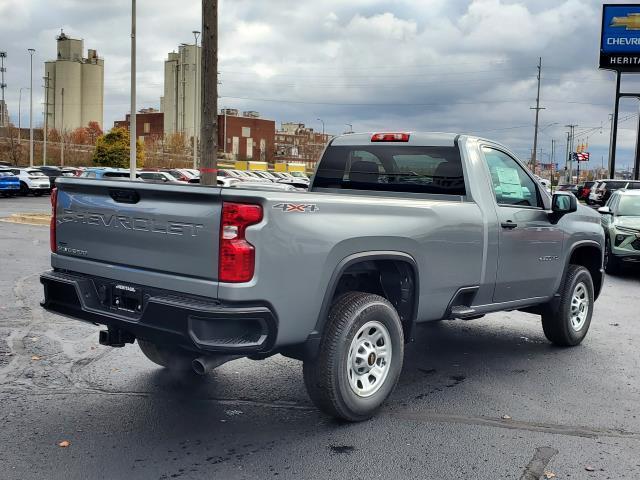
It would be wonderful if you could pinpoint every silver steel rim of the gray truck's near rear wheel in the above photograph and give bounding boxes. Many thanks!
[347,320,393,398]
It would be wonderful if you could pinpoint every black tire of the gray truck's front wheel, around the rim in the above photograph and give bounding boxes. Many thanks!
[542,265,595,347]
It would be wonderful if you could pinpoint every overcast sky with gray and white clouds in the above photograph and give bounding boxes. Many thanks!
[0,0,640,170]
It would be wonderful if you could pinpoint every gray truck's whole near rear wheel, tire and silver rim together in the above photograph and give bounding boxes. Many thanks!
[303,292,404,422]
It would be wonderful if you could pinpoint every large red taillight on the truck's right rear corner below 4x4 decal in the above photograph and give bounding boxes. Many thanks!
[218,202,262,283]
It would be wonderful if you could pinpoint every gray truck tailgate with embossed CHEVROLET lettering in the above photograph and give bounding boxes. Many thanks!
[56,178,222,281]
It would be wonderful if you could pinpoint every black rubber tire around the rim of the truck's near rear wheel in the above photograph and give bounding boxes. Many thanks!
[303,292,404,422]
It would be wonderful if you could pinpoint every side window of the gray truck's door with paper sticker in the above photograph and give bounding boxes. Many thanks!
[482,147,542,208]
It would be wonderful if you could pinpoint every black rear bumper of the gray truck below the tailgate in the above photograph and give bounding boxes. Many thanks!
[40,271,278,355]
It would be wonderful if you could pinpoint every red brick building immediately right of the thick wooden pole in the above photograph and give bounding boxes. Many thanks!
[218,108,276,163]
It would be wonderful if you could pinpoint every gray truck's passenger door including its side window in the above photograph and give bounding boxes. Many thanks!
[482,146,563,303]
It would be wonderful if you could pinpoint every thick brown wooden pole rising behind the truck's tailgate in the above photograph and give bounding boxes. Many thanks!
[200,0,218,185]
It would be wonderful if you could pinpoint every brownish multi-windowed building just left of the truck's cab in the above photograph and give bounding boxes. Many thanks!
[275,122,330,168]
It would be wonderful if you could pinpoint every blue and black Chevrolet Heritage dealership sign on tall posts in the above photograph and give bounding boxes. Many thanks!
[600,4,640,72]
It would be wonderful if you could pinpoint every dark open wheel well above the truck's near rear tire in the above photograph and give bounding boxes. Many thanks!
[331,260,418,341]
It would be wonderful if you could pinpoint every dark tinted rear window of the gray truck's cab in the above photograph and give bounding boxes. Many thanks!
[313,144,466,196]
